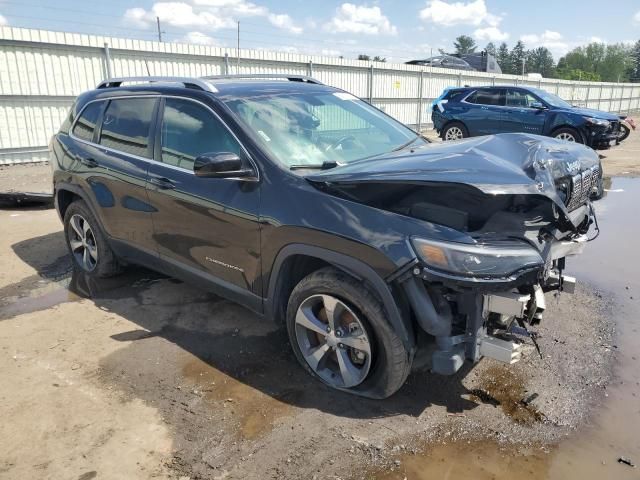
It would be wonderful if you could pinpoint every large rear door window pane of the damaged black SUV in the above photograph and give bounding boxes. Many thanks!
[100,98,156,158]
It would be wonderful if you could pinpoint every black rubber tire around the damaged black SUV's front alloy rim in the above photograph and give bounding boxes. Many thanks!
[286,267,411,399]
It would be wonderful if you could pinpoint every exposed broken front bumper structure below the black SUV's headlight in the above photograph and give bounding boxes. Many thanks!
[398,235,587,375]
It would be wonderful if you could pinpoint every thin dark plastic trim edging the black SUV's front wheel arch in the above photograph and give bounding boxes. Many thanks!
[265,244,416,352]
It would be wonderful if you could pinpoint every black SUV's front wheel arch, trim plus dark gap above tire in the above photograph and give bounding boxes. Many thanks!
[264,244,416,352]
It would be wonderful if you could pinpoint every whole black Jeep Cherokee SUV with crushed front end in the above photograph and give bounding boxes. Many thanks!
[51,76,602,398]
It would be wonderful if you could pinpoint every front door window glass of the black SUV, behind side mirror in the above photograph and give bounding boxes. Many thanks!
[160,98,244,170]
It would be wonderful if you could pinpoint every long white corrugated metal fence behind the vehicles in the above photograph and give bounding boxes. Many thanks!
[0,27,640,165]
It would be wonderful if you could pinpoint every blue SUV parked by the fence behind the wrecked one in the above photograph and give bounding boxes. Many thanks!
[432,86,620,148]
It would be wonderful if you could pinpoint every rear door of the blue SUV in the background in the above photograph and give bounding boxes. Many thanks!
[461,88,505,136]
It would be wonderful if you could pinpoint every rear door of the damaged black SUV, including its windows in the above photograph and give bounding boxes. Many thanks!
[71,97,158,253]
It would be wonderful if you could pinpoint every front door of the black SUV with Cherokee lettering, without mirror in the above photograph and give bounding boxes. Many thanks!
[148,97,260,307]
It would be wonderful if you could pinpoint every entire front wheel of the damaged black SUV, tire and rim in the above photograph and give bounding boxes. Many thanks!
[287,268,411,399]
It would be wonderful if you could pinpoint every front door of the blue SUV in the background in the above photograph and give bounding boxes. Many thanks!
[503,88,547,135]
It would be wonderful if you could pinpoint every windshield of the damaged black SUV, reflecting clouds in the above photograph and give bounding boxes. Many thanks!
[225,91,422,168]
